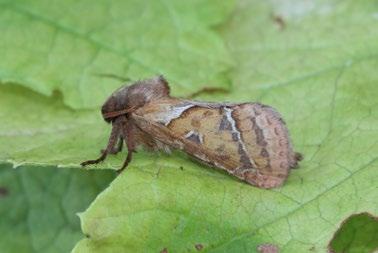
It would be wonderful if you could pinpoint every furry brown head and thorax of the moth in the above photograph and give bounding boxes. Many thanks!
[101,76,169,123]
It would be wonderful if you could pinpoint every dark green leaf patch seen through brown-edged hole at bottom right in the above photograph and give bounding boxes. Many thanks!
[329,213,378,253]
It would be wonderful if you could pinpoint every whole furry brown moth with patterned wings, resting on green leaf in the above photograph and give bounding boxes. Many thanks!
[81,76,302,188]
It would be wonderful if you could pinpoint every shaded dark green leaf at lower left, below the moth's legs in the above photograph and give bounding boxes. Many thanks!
[0,164,114,253]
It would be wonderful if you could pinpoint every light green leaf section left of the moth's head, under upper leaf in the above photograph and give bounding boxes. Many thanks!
[0,85,108,166]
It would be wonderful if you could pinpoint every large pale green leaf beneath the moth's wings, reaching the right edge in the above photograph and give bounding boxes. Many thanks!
[74,0,378,252]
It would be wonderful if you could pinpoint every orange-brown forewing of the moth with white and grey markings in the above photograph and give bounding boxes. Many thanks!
[132,99,295,188]
